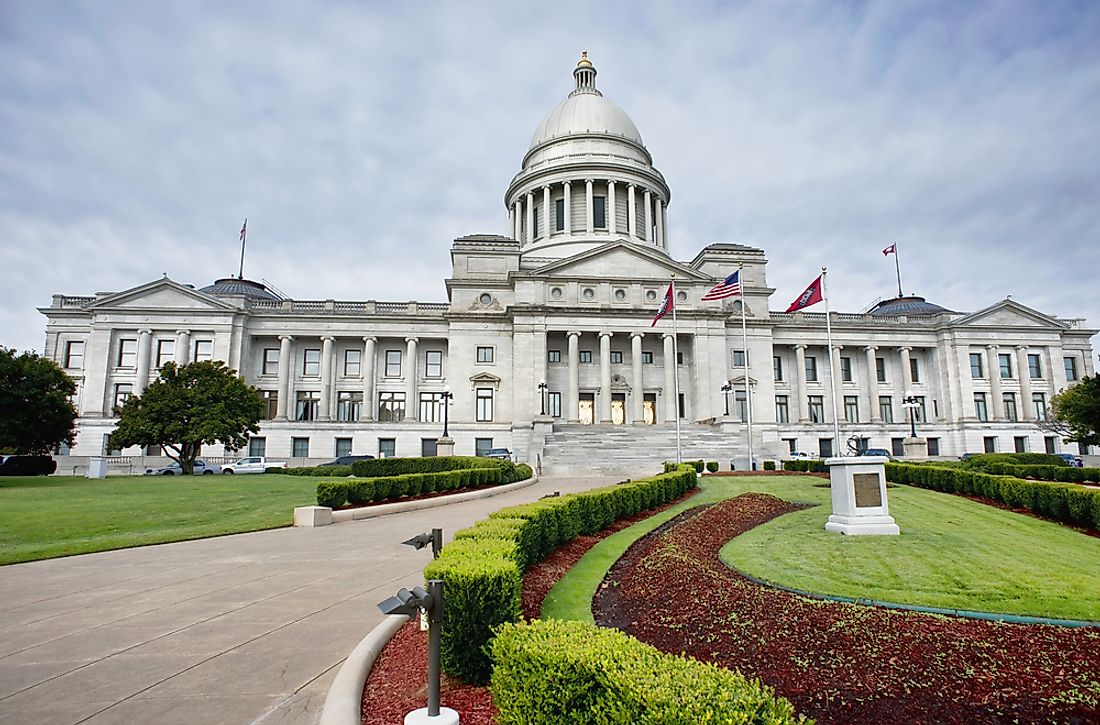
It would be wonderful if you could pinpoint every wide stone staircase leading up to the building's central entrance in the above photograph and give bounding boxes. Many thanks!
[542,424,745,477]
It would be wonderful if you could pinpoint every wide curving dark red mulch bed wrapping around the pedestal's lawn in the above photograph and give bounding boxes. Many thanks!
[594,494,1100,724]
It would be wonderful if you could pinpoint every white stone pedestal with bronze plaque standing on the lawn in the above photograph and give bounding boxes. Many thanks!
[825,455,901,536]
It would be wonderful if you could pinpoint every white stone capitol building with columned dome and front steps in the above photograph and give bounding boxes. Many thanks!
[41,57,1097,472]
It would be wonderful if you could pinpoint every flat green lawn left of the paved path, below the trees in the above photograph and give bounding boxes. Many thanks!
[0,474,317,564]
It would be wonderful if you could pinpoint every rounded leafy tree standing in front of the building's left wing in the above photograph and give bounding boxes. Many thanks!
[111,360,264,474]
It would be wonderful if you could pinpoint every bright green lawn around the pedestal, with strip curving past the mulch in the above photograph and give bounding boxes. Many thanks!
[542,476,1100,622]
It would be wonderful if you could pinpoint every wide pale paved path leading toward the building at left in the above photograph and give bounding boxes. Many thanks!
[0,477,615,725]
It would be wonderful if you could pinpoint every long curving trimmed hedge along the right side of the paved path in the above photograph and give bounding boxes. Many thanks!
[424,464,696,683]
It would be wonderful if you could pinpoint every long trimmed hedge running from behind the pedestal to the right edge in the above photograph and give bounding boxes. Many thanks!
[887,463,1100,530]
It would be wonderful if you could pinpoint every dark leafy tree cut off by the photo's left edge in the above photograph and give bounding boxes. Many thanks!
[0,348,76,454]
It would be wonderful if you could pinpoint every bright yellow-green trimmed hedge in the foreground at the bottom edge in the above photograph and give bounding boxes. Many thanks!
[491,620,806,725]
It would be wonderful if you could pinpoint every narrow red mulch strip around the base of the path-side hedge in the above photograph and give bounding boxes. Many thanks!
[362,490,697,725]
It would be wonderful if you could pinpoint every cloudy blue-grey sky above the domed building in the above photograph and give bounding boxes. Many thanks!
[0,0,1100,350]
